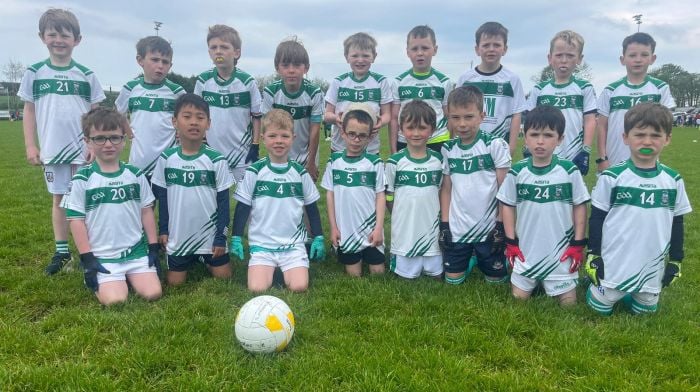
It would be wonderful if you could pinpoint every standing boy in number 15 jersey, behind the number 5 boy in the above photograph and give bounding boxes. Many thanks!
[324,33,393,154]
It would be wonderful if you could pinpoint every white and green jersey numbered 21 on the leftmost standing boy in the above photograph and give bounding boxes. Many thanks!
[17,59,105,165]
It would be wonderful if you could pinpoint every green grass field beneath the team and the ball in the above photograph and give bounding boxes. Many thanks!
[0,122,700,391]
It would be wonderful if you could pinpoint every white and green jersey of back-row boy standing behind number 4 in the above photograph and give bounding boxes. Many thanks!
[261,79,323,166]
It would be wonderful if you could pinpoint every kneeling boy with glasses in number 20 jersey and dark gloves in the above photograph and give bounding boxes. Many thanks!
[63,108,162,305]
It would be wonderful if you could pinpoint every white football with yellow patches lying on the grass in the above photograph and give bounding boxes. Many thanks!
[234,295,294,353]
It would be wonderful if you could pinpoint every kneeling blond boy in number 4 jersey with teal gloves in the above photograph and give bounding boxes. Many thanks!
[229,109,326,292]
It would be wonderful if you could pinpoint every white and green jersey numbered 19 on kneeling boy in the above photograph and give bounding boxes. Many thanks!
[151,145,235,256]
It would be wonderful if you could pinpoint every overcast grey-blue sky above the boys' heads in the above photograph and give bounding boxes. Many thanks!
[0,0,700,92]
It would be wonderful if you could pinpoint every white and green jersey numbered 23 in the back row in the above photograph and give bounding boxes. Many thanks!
[525,78,598,160]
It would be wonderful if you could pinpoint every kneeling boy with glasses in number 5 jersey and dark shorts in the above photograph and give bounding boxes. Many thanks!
[321,103,385,276]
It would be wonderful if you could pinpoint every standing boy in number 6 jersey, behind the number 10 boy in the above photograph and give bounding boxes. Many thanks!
[389,26,454,154]
